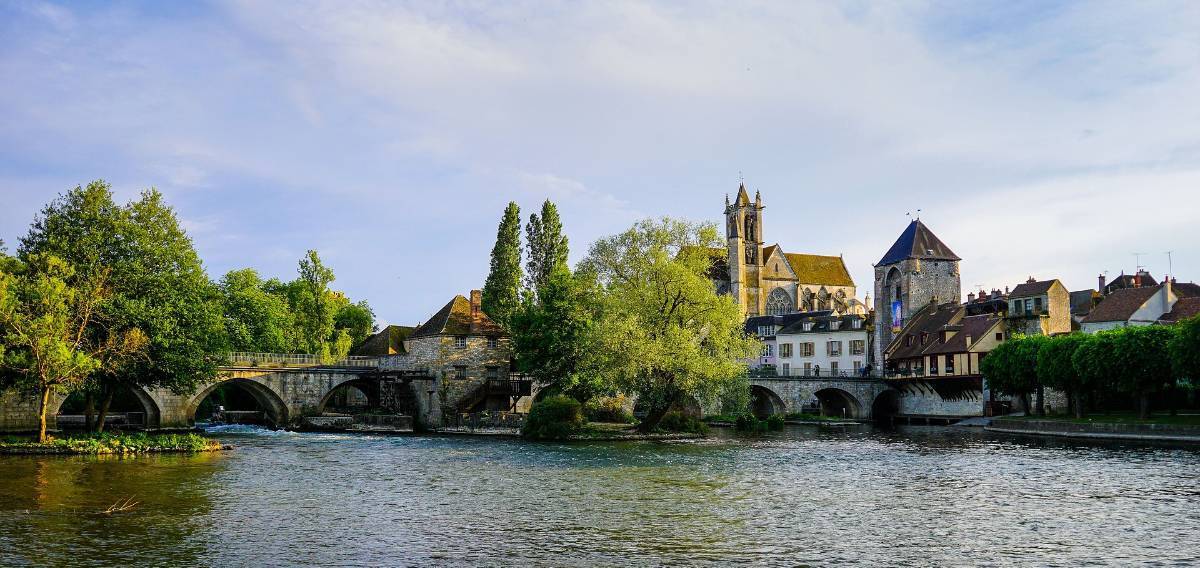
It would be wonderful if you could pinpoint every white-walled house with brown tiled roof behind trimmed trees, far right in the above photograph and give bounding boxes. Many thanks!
[1081,280,1200,334]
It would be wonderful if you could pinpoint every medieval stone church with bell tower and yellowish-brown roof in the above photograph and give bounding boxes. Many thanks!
[712,184,866,317]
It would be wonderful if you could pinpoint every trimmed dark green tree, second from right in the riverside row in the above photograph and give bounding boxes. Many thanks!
[1115,325,1175,420]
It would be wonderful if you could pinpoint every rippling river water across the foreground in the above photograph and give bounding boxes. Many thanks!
[0,426,1200,567]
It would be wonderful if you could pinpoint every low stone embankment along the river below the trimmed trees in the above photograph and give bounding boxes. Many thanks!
[984,417,1200,444]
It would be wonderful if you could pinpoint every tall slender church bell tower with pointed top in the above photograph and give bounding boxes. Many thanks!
[725,184,764,317]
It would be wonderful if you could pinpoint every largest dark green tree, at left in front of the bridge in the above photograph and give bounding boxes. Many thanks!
[18,181,224,429]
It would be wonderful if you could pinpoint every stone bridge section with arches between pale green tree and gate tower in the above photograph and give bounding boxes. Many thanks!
[750,377,900,420]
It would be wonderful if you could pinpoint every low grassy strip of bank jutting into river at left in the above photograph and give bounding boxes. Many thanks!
[0,432,224,455]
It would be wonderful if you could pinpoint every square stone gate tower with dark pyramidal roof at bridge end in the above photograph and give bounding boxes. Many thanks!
[875,219,962,366]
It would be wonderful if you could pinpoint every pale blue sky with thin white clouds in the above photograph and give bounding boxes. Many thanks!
[0,0,1200,324]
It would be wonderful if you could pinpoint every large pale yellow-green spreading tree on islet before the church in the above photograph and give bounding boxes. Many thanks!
[581,219,758,431]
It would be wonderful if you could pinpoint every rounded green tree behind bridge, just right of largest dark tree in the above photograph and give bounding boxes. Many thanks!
[218,268,299,353]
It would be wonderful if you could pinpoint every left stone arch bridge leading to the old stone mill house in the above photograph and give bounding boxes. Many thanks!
[0,361,442,431]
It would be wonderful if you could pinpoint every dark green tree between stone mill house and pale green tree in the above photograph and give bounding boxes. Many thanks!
[511,267,607,402]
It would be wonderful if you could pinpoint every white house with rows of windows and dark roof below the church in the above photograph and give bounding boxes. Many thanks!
[775,312,871,377]
